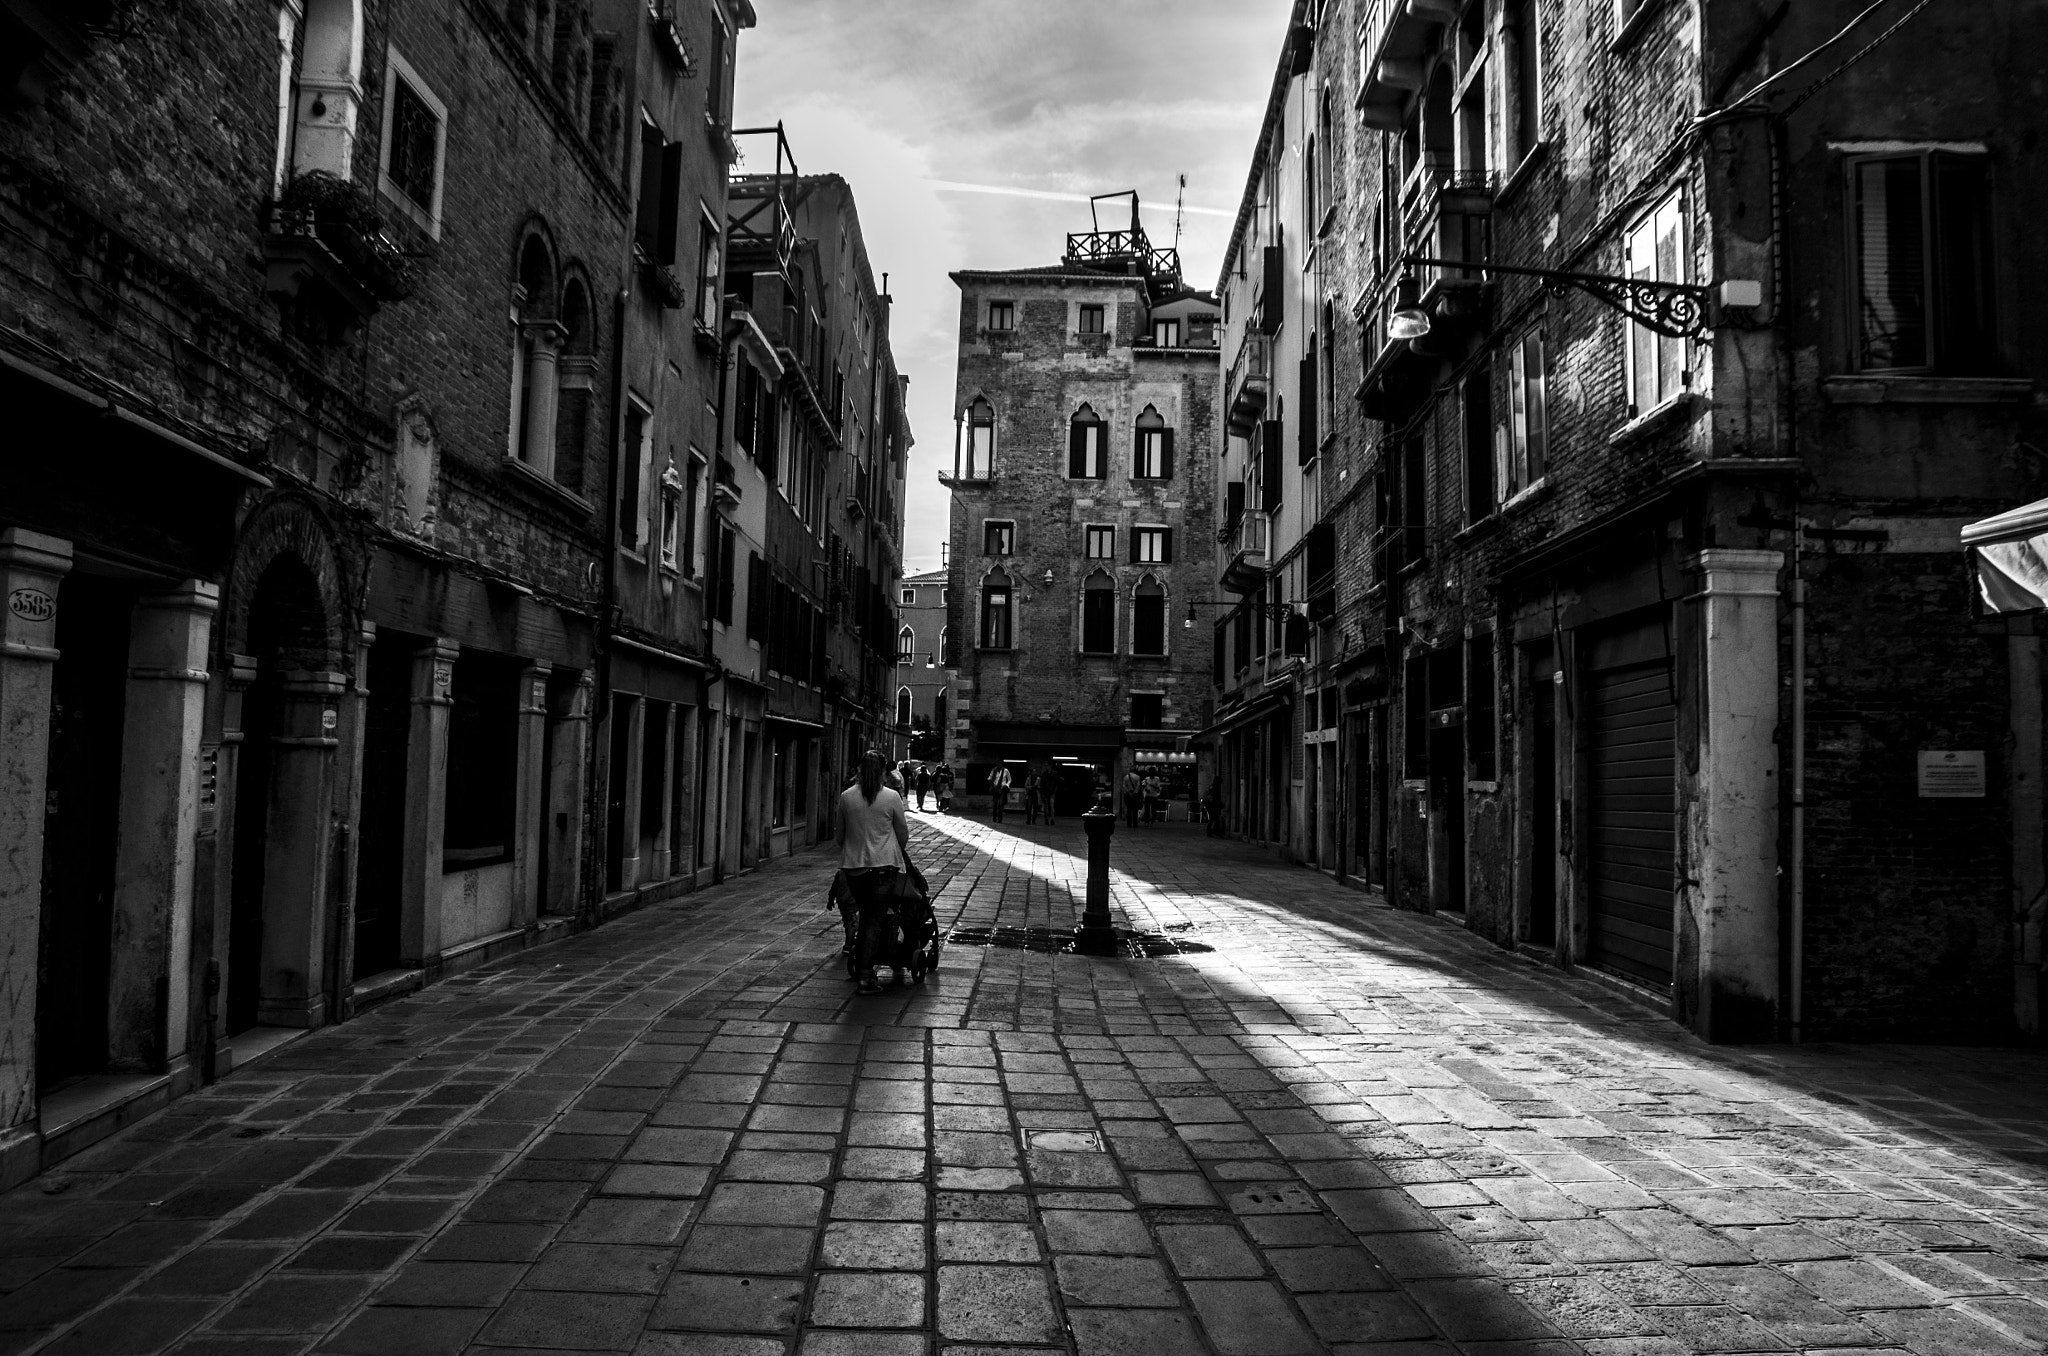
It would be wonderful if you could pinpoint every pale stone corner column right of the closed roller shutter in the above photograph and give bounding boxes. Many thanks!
[1681,549,1784,1041]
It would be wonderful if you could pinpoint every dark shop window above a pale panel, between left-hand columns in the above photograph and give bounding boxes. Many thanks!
[440,649,522,871]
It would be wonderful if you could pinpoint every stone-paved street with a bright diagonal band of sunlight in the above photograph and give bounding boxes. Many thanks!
[0,815,2048,1356]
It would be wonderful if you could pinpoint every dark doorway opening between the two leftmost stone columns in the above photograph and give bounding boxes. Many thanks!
[35,574,135,1088]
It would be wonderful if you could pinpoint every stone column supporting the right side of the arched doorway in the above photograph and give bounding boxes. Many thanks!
[256,672,348,1026]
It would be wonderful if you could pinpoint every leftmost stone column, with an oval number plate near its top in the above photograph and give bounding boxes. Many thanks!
[0,526,72,1147]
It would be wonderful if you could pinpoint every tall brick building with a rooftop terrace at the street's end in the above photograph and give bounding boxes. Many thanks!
[942,195,1219,813]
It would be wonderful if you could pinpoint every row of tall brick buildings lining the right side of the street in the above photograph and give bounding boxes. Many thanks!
[1217,0,2048,1041]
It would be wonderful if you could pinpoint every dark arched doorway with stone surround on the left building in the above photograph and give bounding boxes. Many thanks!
[215,522,346,1036]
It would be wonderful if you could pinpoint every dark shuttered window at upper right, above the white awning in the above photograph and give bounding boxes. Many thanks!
[1849,152,1997,375]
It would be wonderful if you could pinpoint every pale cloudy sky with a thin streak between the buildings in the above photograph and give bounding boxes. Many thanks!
[735,0,1290,574]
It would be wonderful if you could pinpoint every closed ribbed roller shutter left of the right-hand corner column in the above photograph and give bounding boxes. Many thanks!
[1587,660,1677,985]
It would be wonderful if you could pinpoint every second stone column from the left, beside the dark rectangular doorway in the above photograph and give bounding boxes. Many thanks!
[106,580,221,1073]
